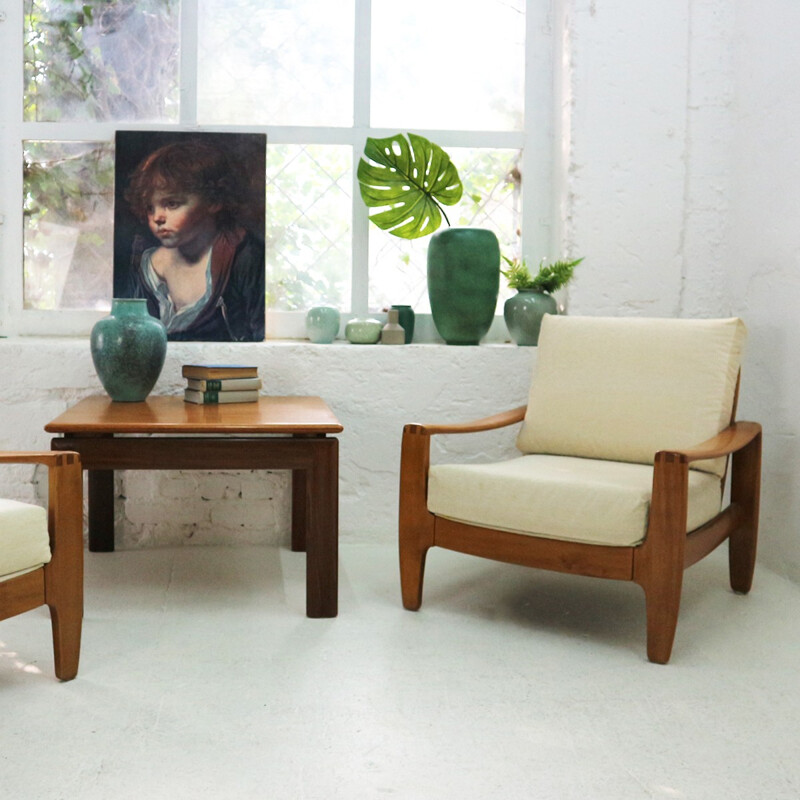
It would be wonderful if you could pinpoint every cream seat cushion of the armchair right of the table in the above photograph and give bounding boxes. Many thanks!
[428,455,722,546]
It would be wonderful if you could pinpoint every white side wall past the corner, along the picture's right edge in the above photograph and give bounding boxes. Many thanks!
[729,0,800,578]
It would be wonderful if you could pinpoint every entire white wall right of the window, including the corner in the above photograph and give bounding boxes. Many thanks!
[565,0,800,578]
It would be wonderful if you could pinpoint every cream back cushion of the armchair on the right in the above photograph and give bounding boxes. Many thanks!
[517,315,746,476]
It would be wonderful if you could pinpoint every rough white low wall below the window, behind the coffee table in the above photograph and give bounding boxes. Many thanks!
[0,338,535,549]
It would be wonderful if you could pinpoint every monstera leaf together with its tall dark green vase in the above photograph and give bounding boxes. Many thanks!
[356,133,500,344]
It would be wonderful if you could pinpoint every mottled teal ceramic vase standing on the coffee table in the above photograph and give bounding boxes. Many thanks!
[90,298,167,403]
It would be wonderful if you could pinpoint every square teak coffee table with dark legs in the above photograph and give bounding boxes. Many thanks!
[44,396,343,617]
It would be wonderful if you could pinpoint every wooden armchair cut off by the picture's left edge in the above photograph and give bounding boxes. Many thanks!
[0,451,83,681]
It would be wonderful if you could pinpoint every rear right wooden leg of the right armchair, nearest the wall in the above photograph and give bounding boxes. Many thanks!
[728,434,761,594]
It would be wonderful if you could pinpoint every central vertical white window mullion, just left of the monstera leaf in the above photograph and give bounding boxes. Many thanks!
[350,0,372,314]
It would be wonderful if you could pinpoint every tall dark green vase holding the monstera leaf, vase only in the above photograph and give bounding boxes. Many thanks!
[428,228,500,345]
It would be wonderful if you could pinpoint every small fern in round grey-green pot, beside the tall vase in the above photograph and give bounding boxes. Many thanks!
[501,256,583,346]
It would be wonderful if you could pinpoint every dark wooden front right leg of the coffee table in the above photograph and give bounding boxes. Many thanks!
[306,438,339,617]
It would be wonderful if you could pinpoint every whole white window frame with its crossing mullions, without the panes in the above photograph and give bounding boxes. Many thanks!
[6,0,544,335]
